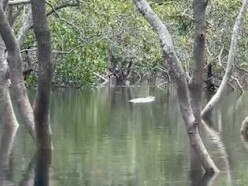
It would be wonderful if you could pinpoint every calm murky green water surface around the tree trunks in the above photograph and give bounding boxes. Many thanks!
[0,87,248,186]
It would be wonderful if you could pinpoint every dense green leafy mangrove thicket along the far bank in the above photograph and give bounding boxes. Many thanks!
[20,0,248,87]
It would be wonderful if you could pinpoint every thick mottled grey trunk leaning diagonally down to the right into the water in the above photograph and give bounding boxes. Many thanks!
[133,0,218,172]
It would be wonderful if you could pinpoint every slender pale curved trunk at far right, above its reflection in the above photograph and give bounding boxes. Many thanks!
[201,0,248,117]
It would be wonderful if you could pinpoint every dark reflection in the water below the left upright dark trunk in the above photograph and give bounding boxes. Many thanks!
[34,150,52,186]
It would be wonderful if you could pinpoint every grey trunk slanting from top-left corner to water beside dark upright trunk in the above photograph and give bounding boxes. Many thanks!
[0,1,35,138]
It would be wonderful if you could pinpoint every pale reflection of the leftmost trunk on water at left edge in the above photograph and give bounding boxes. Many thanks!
[0,123,18,186]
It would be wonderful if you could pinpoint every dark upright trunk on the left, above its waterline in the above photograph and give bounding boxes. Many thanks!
[31,0,53,149]
